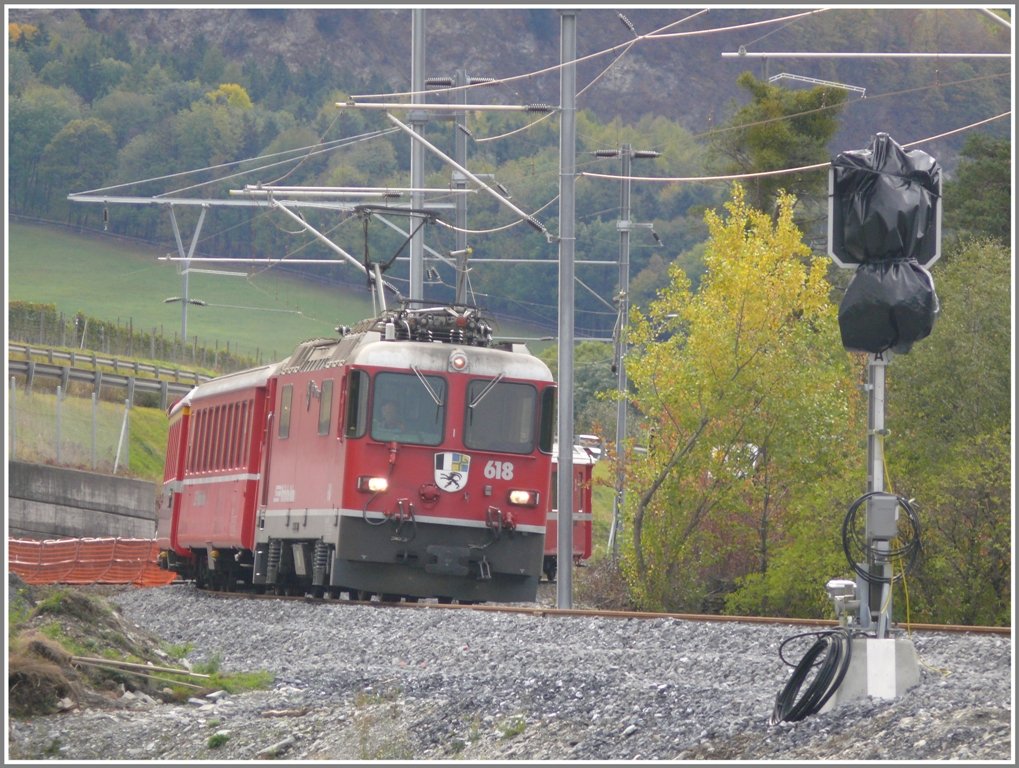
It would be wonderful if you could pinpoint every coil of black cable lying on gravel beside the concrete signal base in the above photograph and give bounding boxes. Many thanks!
[768,627,853,725]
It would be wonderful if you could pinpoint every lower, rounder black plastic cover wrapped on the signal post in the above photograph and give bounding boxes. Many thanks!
[839,259,938,354]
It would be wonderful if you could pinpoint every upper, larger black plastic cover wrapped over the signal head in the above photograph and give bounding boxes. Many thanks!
[832,133,942,266]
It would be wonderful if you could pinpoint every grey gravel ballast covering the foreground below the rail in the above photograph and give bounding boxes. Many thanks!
[8,585,1014,763]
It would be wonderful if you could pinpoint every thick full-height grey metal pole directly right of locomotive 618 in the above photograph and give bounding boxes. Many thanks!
[556,4,577,608]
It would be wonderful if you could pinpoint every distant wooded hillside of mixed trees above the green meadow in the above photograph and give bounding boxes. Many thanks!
[8,10,722,338]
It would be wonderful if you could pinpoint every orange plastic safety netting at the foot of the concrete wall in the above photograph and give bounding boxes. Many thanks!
[7,539,176,587]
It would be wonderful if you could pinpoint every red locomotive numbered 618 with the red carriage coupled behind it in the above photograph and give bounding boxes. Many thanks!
[158,301,555,602]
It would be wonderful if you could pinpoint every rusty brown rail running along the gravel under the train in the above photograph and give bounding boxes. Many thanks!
[192,588,1012,637]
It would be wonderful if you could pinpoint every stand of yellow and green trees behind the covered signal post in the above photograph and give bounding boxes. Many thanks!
[621,136,1014,625]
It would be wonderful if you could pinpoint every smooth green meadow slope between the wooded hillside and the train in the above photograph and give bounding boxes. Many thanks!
[6,223,372,360]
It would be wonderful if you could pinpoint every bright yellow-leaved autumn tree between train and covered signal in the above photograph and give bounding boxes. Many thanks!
[623,185,862,613]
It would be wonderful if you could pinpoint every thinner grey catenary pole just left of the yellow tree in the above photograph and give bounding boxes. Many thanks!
[608,144,633,562]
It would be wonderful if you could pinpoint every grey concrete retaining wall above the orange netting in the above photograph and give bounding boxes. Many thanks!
[6,461,156,539]
